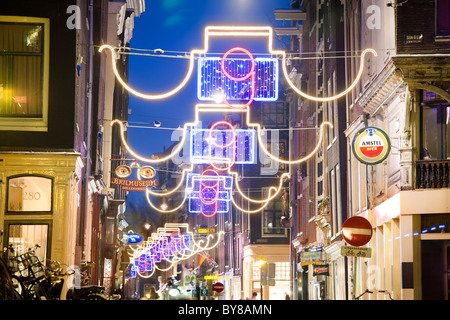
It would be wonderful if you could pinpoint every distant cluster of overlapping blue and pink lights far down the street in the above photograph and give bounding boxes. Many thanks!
[130,223,224,278]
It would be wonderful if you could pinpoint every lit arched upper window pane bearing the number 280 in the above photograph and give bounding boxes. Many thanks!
[7,176,53,214]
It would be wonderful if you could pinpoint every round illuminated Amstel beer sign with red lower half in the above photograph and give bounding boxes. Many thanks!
[352,127,391,165]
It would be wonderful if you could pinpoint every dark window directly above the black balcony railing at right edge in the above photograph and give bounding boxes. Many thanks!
[421,98,450,160]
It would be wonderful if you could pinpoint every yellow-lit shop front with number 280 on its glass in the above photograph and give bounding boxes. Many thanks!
[0,153,83,265]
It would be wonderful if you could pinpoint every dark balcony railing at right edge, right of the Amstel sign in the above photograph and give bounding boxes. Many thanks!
[416,160,450,189]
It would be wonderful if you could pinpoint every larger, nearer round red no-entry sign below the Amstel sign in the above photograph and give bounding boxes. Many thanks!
[342,216,373,247]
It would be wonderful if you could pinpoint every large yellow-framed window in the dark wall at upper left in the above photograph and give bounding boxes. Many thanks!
[0,16,49,131]
